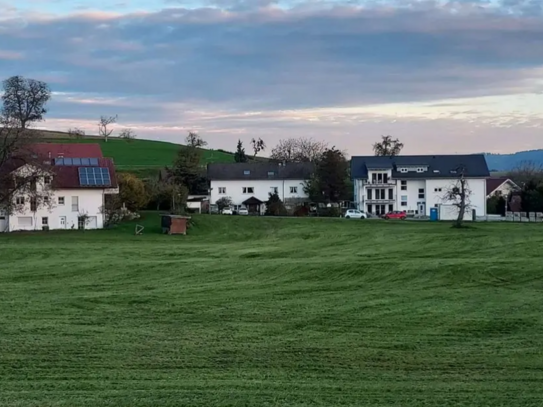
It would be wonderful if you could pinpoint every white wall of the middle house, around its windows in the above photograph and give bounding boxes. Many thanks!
[211,179,307,205]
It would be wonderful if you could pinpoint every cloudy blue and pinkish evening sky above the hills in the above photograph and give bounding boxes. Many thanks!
[0,0,543,155]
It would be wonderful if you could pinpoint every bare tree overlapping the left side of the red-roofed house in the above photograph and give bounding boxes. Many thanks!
[0,116,54,218]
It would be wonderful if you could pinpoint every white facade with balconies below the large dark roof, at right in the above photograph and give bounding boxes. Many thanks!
[354,170,486,216]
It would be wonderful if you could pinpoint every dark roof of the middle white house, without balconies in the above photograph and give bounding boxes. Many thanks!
[207,162,315,181]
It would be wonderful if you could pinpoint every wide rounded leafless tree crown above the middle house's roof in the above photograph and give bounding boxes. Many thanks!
[270,137,327,162]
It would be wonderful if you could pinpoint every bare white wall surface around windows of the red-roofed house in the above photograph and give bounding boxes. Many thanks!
[9,189,104,231]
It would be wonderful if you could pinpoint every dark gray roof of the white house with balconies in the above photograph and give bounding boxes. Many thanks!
[351,154,490,179]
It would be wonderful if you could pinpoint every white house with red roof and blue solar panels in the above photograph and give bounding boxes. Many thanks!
[0,144,118,232]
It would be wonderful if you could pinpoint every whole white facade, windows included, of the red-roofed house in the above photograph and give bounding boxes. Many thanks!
[7,189,104,232]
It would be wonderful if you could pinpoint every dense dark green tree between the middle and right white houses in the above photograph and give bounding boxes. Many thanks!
[304,147,350,203]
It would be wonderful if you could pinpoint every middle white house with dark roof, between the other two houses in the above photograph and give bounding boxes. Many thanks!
[207,161,314,213]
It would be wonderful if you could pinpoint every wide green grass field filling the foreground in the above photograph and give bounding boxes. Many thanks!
[0,215,543,407]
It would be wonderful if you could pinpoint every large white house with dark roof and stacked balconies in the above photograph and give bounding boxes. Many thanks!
[351,154,489,216]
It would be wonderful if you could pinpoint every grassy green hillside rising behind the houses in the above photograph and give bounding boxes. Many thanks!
[33,130,234,177]
